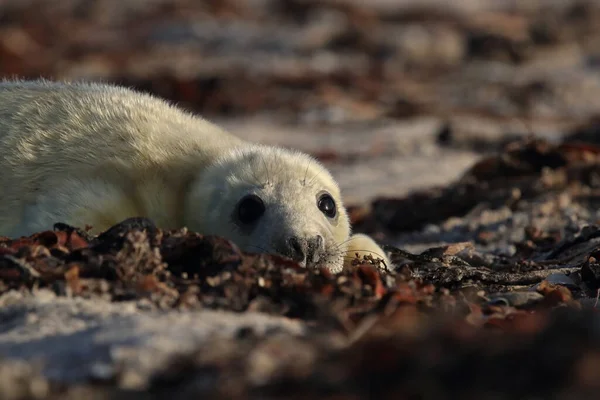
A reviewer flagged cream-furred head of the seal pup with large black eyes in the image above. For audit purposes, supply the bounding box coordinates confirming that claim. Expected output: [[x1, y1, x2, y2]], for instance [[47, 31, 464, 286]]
[[185, 145, 350, 272]]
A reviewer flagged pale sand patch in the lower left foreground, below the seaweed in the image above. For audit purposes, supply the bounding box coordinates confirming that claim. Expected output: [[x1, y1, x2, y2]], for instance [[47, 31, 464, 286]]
[[0, 291, 305, 390]]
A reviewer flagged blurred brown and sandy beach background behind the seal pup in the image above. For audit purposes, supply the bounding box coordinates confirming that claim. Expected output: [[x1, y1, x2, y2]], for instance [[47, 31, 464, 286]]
[[0, 0, 600, 204]]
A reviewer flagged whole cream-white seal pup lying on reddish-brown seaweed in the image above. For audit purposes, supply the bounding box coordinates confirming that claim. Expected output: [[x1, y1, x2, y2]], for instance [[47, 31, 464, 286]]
[[0, 80, 387, 272]]
